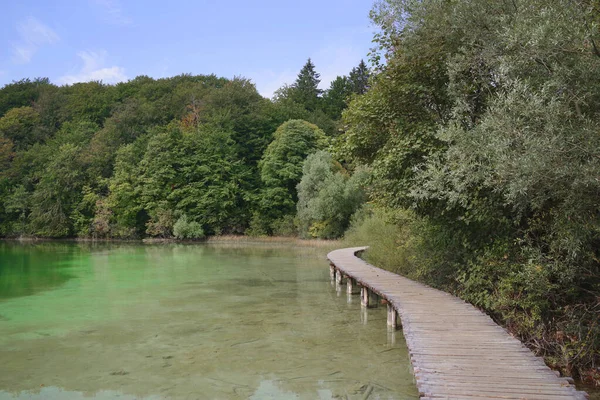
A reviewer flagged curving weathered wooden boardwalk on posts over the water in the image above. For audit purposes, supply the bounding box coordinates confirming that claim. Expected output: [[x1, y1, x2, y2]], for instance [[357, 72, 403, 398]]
[[327, 247, 587, 400]]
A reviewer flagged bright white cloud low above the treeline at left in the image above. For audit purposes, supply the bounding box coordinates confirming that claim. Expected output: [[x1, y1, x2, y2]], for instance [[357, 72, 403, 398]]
[[57, 51, 128, 85]]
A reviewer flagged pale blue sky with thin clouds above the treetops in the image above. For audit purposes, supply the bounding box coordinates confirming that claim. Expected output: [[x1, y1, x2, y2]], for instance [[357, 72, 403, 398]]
[[0, 0, 375, 97]]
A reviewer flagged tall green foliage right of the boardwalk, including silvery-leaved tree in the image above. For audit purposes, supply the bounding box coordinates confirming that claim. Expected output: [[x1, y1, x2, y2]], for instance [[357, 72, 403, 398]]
[[336, 0, 600, 377]]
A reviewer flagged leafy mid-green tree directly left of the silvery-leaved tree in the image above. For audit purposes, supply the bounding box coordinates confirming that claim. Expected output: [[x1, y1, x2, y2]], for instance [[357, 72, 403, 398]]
[[336, 43, 451, 207]]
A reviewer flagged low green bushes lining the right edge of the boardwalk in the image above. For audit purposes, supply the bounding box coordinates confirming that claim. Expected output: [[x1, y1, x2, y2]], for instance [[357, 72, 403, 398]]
[[345, 205, 600, 383]]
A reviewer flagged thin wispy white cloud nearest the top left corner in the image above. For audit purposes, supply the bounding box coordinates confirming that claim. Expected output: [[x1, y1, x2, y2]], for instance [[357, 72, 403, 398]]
[[12, 17, 60, 64]]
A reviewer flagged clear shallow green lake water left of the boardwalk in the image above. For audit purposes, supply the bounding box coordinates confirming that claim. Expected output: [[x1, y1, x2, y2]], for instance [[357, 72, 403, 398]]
[[0, 243, 418, 400]]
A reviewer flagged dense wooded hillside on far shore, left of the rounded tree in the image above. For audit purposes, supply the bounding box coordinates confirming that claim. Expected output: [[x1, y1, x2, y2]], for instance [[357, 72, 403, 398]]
[[0, 75, 284, 238]]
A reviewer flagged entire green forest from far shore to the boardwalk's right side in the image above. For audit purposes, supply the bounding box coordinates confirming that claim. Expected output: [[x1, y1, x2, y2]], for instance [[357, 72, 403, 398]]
[[0, 0, 600, 384]]
